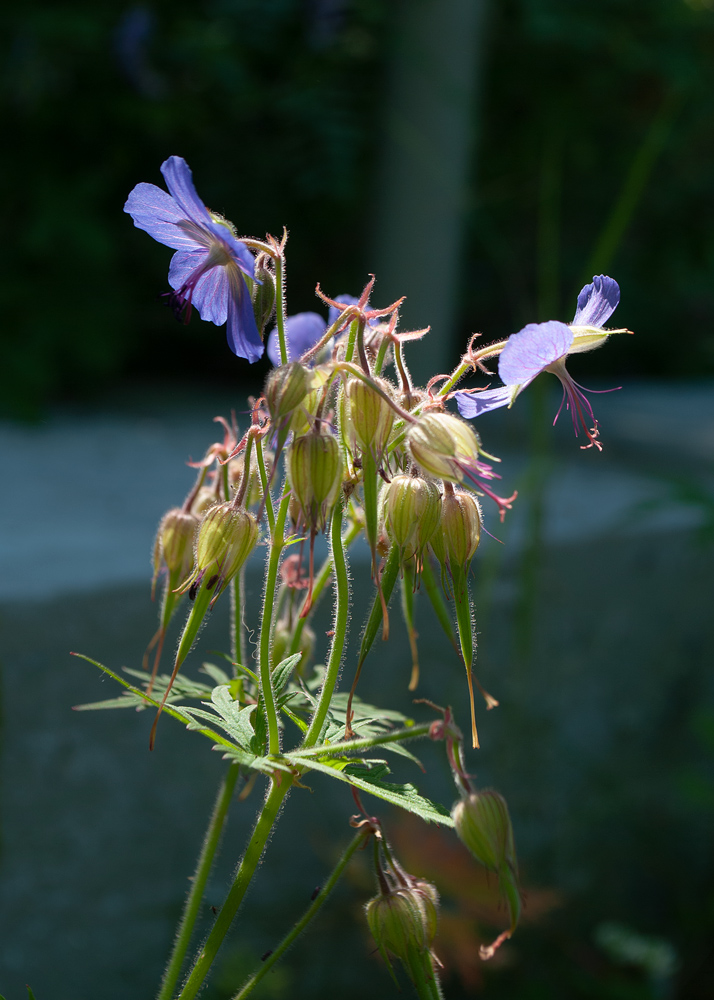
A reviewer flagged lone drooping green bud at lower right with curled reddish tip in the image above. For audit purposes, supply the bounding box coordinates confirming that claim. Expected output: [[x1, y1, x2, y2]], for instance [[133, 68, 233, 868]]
[[451, 788, 521, 958]]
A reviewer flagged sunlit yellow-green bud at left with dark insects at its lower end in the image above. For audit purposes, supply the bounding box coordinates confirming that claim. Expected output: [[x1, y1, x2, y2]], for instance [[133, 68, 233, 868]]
[[181, 501, 258, 605]]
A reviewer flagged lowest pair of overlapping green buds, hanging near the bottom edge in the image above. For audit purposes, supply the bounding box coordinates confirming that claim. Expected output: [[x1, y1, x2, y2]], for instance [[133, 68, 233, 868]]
[[365, 844, 439, 984]]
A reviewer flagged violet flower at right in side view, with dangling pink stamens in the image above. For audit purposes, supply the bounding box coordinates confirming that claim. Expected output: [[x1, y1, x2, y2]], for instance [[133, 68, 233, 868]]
[[454, 274, 627, 448]]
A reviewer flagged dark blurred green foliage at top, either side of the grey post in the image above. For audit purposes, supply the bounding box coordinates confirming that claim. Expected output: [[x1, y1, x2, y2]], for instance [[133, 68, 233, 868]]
[[0, 0, 714, 417]]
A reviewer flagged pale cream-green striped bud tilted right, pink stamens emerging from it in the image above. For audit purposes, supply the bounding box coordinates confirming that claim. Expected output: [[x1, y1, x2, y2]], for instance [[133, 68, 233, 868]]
[[407, 413, 479, 483]]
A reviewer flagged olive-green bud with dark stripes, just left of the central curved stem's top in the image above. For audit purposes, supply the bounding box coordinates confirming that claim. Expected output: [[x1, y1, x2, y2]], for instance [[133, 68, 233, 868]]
[[287, 431, 342, 531]]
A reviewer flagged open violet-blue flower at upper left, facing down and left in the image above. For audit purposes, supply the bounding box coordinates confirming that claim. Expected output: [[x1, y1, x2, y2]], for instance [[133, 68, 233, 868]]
[[124, 156, 263, 362]]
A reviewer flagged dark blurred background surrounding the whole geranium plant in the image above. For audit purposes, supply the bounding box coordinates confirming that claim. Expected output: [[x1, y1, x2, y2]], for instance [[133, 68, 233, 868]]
[[0, 0, 714, 1000]]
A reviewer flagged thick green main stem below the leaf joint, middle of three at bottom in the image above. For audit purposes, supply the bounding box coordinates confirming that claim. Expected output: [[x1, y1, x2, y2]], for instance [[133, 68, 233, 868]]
[[179, 773, 292, 1000]]
